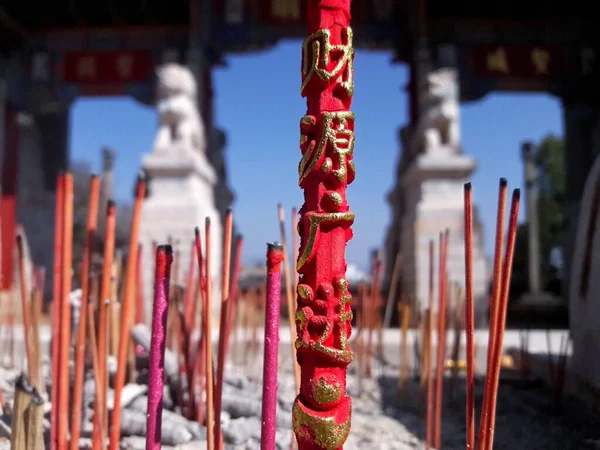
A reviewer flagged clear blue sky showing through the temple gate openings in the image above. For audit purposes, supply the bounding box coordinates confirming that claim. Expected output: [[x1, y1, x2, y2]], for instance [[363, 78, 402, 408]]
[[71, 41, 563, 268]]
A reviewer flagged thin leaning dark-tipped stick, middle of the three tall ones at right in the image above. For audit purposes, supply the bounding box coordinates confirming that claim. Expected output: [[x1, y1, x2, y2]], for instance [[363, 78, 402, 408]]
[[479, 178, 507, 450]]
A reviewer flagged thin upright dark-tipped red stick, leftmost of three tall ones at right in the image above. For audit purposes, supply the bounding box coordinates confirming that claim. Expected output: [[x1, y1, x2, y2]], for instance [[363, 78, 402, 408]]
[[465, 183, 475, 450]]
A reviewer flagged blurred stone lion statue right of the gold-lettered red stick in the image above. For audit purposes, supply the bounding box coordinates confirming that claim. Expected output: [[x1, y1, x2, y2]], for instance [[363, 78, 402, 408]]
[[411, 69, 460, 153]]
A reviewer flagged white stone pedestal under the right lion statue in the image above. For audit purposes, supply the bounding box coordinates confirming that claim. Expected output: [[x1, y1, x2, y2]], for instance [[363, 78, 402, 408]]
[[400, 151, 487, 317]]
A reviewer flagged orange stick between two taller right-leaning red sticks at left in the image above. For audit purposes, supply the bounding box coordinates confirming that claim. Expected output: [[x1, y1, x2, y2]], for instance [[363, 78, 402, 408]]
[[92, 201, 116, 450]]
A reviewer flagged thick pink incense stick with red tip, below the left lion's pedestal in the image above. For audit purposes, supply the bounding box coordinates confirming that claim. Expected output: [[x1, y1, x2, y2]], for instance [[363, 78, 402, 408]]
[[146, 245, 173, 450]]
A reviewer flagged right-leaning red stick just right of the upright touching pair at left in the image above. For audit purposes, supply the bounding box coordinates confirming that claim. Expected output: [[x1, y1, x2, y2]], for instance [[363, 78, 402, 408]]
[[71, 175, 101, 450]]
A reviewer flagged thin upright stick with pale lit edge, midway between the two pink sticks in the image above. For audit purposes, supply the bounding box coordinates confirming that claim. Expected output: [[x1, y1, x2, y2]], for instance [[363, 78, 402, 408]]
[[204, 217, 215, 450]]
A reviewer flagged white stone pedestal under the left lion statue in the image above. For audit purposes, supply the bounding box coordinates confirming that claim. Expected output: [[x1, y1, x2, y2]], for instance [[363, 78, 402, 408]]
[[140, 148, 223, 324]]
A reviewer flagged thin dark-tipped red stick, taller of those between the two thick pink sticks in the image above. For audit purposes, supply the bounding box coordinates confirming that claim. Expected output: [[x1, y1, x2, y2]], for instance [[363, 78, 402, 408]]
[[215, 210, 233, 450]]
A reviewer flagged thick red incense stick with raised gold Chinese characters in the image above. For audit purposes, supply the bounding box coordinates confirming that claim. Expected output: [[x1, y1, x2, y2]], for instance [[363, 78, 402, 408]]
[[292, 0, 355, 450]]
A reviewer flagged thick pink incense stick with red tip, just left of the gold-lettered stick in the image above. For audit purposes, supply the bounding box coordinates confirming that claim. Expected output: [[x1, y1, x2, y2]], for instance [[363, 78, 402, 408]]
[[260, 243, 283, 450]]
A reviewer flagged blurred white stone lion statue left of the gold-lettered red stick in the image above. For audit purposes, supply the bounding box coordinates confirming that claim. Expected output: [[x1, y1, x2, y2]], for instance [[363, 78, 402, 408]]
[[154, 63, 206, 153]]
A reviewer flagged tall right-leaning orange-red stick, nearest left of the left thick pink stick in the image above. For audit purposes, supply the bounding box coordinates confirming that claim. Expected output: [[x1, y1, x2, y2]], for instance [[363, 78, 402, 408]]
[[110, 178, 146, 450]]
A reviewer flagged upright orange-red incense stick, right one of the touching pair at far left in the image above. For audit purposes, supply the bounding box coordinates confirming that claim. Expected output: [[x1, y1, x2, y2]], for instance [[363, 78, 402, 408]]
[[58, 173, 73, 450]]
